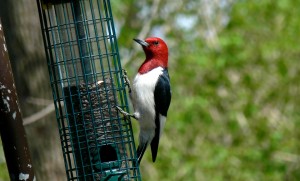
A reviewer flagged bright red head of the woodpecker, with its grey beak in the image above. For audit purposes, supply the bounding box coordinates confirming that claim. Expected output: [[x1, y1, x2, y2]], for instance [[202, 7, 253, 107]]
[[134, 37, 168, 73]]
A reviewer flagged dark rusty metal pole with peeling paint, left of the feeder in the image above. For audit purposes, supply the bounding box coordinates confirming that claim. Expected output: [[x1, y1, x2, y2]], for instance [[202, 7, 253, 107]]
[[0, 19, 35, 181]]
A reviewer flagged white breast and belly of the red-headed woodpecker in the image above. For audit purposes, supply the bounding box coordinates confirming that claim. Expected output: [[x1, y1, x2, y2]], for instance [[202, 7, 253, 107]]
[[132, 67, 163, 130]]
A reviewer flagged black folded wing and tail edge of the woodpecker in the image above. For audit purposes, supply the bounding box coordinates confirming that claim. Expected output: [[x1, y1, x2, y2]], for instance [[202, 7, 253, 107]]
[[151, 69, 171, 162]]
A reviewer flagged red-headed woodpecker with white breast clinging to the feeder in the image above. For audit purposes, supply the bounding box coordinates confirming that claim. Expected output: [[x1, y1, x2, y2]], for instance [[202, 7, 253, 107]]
[[130, 37, 171, 163]]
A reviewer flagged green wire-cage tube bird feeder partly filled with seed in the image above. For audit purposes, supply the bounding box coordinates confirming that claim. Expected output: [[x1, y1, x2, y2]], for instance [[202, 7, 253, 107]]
[[37, 0, 141, 180]]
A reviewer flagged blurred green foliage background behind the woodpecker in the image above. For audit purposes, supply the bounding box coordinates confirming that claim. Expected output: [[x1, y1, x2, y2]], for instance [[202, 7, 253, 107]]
[[0, 0, 300, 181]]
